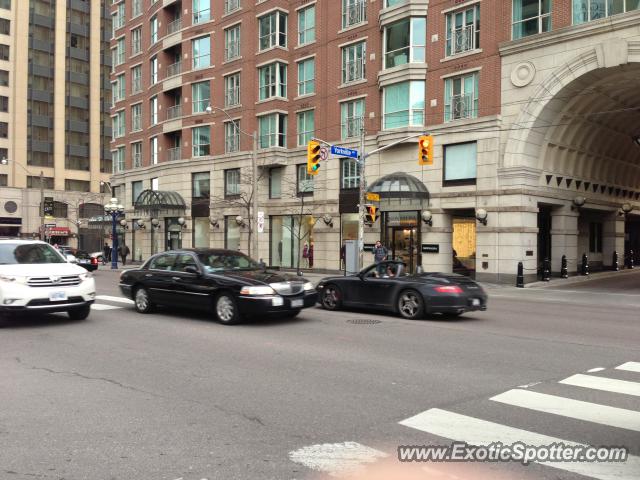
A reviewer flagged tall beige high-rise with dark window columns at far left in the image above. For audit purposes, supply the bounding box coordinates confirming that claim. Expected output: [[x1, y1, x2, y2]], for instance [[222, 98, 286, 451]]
[[0, 0, 111, 250]]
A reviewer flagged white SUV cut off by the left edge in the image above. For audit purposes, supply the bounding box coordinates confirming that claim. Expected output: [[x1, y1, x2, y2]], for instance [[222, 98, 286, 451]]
[[0, 240, 96, 320]]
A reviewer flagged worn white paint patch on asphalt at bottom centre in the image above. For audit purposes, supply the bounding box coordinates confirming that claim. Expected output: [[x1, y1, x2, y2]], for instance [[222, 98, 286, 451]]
[[289, 442, 388, 477]]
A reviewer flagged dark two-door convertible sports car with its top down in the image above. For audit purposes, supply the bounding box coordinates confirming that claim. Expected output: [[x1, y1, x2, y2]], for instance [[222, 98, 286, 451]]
[[316, 261, 487, 319]]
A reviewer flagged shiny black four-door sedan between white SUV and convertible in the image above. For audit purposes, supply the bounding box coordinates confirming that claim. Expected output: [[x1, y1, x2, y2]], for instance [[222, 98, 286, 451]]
[[120, 249, 318, 325]]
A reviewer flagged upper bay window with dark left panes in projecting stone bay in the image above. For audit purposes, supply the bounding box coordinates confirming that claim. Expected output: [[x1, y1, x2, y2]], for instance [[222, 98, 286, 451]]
[[384, 18, 427, 68]]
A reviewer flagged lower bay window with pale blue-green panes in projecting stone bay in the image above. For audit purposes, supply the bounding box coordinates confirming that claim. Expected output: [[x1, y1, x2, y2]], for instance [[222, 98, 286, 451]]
[[383, 81, 425, 130]]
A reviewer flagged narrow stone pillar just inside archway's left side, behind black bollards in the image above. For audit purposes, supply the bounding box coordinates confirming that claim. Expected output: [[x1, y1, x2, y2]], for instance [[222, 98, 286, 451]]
[[551, 206, 581, 274]]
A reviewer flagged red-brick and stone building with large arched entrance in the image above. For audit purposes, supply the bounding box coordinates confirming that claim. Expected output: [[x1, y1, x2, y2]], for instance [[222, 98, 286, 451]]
[[111, 0, 640, 282]]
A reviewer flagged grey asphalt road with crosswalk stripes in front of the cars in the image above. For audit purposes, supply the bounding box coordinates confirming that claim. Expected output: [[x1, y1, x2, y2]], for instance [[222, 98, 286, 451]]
[[0, 270, 640, 480]]
